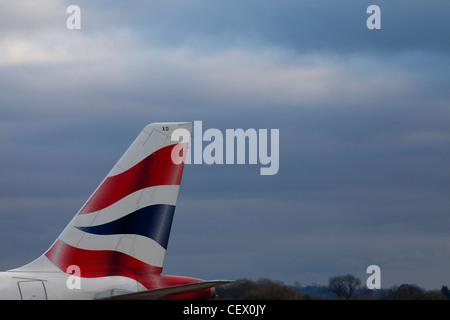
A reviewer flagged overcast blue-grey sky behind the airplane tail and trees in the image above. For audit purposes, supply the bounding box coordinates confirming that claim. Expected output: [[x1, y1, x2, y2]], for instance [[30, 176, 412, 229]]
[[0, 0, 450, 289]]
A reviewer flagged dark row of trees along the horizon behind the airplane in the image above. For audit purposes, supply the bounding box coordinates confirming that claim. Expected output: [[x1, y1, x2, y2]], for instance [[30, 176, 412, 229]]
[[216, 275, 450, 300]]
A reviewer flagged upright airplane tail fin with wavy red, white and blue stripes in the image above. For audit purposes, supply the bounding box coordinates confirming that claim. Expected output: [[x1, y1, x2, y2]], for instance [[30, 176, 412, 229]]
[[16, 122, 192, 278]]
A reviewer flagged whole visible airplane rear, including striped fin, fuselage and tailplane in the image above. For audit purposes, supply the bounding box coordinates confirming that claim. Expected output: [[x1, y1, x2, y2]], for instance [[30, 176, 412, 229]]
[[0, 122, 229, 299]]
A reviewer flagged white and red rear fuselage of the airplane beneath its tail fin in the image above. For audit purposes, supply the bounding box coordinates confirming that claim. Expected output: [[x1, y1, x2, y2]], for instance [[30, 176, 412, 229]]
[[0, 271, 215, 300]]
